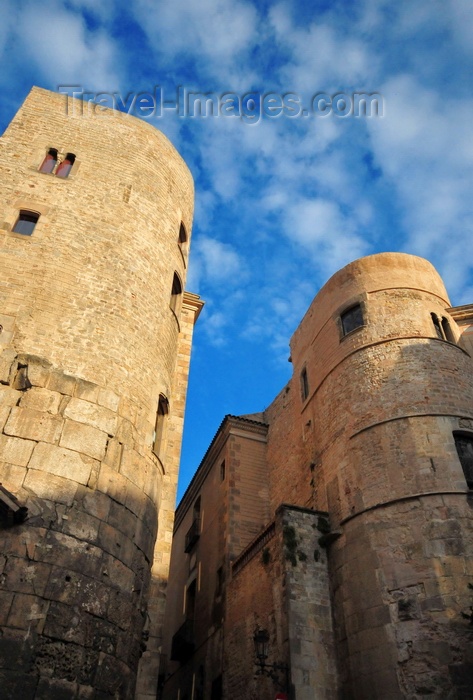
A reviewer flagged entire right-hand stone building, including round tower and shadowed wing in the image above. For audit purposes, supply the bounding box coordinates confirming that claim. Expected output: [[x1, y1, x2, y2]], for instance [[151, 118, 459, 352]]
[[160, 253, 473, 700]]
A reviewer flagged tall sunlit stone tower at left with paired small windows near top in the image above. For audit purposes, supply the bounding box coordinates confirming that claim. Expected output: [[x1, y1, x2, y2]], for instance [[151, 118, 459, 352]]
[[0, 88, 202, 700]]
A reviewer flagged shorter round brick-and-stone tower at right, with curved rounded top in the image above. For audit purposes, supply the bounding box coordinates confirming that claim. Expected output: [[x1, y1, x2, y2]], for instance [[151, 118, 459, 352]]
[[291, 253, 473, 700]]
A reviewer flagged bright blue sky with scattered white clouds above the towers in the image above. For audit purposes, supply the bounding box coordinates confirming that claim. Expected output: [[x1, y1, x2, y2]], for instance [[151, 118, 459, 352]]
[[0, 0, 473, 504]]
